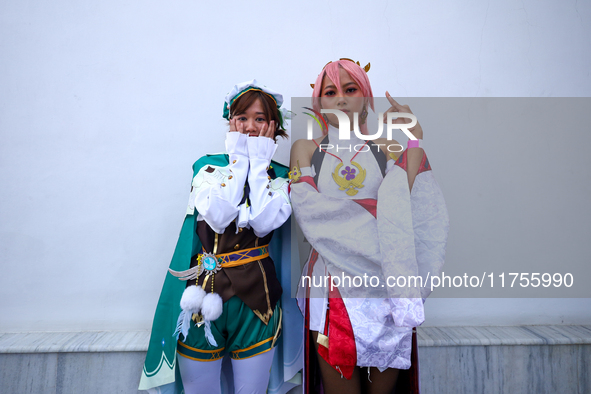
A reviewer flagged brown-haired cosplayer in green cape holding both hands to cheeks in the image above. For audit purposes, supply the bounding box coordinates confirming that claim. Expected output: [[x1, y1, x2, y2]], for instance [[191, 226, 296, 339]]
[[140, 80, 291, 394]]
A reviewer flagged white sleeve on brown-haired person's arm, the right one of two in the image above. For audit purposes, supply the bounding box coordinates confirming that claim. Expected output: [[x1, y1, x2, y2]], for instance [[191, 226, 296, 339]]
[[248, 137, 291, 237]]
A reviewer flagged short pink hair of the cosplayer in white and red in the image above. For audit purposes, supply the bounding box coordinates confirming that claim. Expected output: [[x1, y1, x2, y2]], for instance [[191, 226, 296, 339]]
[[312, 60, 375, 135]]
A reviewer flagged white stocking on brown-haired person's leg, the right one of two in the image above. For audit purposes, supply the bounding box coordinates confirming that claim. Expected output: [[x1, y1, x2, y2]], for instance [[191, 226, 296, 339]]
[[232, 348, 275, 394]]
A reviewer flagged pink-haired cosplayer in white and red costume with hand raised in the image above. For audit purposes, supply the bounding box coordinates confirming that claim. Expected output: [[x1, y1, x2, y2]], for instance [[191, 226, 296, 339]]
[[290, 59, 449, 394]]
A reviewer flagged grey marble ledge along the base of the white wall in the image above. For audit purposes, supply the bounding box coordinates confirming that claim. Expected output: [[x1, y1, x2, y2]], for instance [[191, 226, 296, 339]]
[[0, 326, 591, 394]]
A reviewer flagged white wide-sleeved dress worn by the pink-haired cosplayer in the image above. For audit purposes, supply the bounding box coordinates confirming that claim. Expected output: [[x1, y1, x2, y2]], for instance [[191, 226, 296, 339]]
[[291, 126, 448, 370]]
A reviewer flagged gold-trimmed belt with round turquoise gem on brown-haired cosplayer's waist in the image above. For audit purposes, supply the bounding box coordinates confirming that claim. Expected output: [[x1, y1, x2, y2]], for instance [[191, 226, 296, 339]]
[[168, 245, 269, 280]]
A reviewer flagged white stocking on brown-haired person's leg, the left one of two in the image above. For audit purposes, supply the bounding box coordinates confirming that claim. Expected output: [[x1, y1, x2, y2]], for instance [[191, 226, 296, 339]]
[[177, 355, 222, 394]]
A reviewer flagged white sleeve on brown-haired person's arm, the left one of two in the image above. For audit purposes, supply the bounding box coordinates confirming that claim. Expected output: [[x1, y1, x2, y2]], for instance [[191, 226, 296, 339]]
[[191, 132, 249, 234]]
